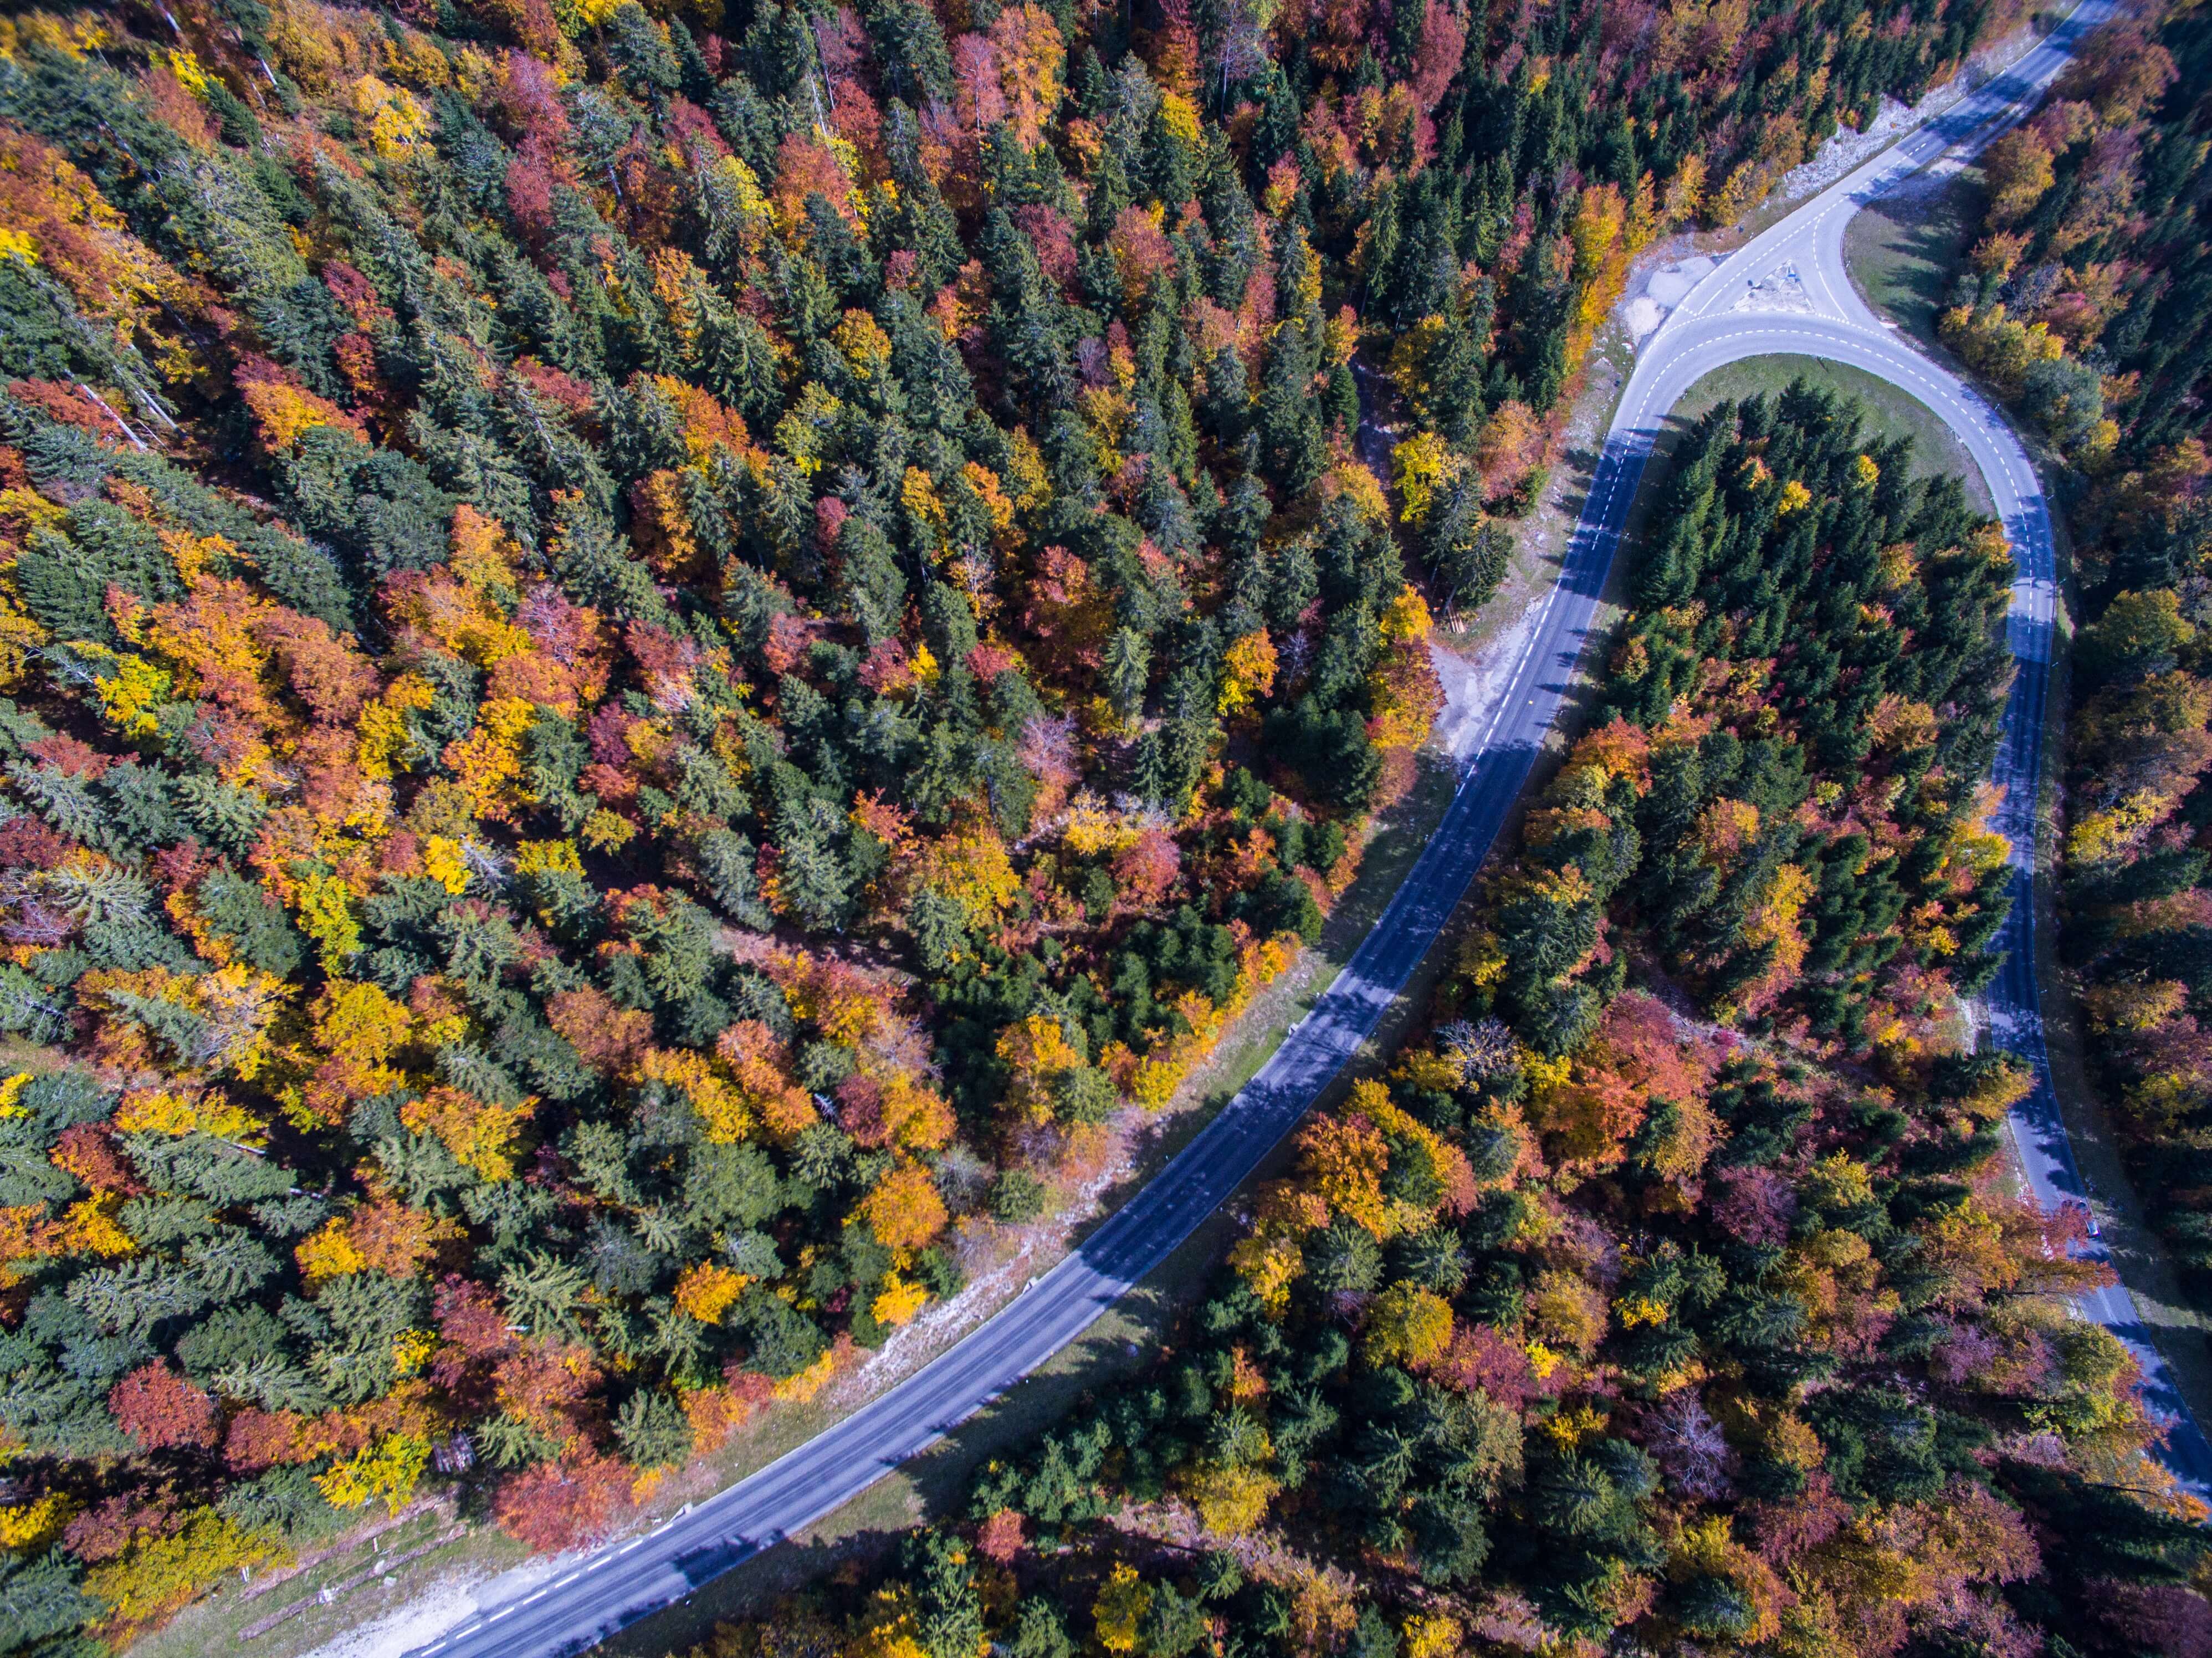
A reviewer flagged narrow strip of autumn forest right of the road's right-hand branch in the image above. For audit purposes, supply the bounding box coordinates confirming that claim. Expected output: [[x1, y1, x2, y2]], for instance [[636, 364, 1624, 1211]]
[[1944, 7, 2212, 1304]]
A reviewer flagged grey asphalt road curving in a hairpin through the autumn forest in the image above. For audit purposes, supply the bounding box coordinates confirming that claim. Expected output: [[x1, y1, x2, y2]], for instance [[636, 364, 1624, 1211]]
[[412, 0, 2212, 1658]]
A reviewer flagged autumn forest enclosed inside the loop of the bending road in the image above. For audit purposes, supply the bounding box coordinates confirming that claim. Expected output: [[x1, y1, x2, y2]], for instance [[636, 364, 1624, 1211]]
[[654, 383, 2212, 1658]]
